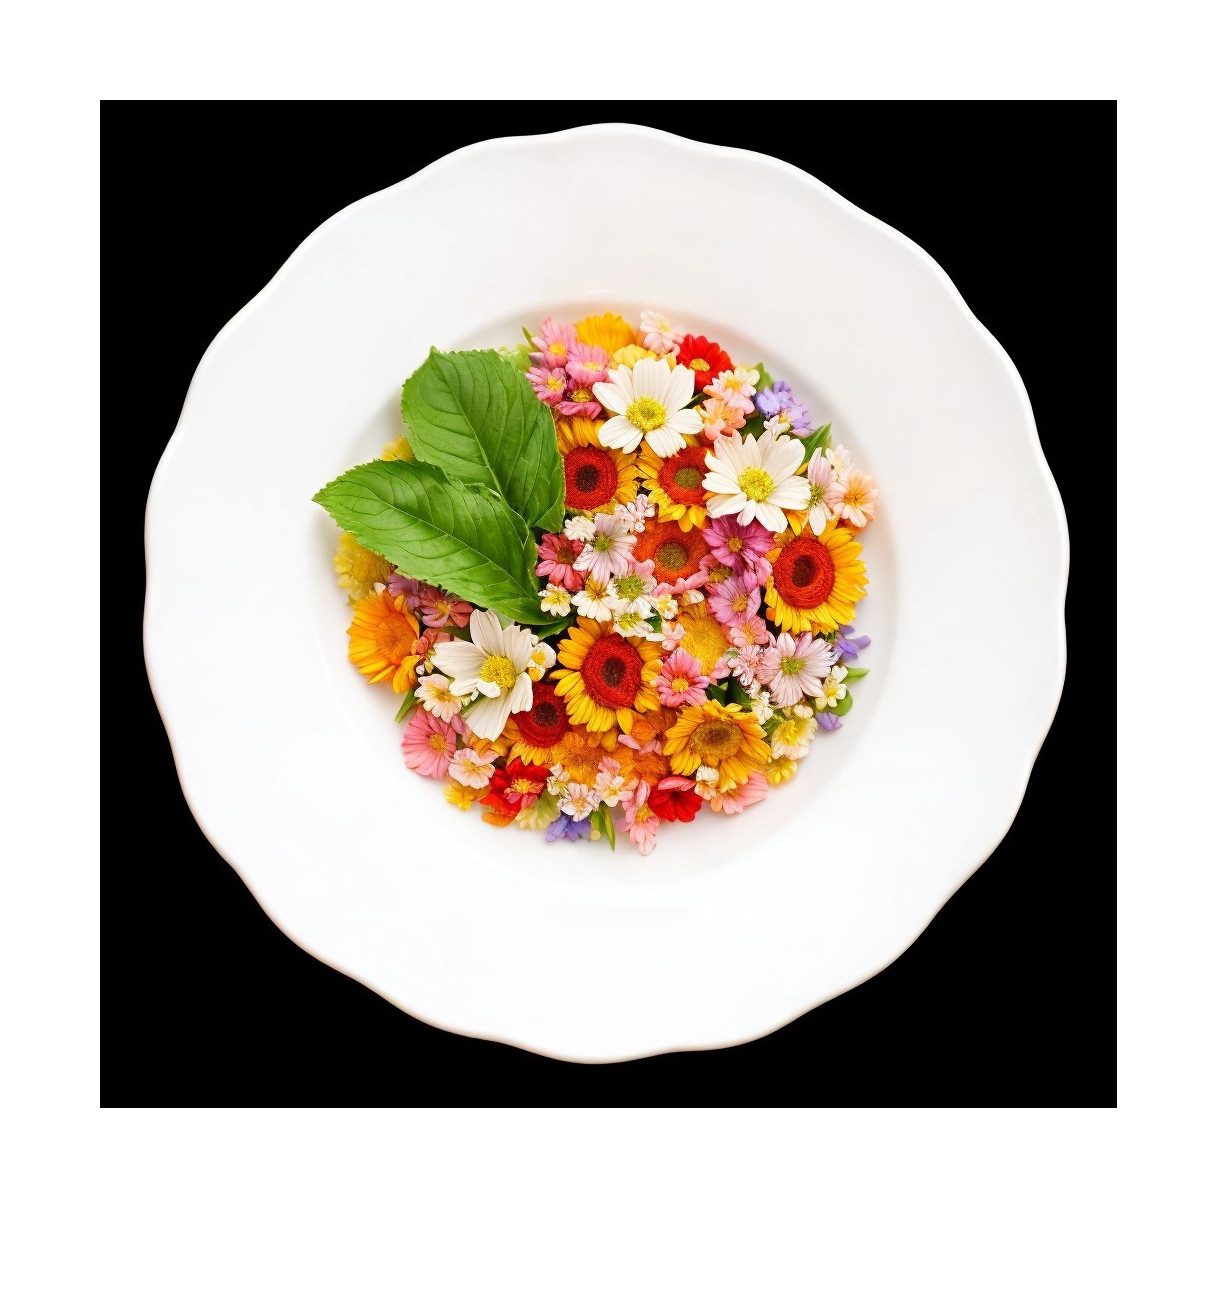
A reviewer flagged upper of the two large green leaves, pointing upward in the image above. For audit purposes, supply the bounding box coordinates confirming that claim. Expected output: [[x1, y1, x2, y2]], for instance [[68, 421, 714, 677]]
[[401, 350, 565, 534]]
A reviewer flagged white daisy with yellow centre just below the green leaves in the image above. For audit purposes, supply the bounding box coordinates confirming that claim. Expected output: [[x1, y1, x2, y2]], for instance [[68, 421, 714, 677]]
[[435, 609, 537, 741]]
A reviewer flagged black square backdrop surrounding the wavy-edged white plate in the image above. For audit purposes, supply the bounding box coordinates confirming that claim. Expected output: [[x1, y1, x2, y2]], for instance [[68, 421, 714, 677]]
[[103, 103, 1115, 1105]]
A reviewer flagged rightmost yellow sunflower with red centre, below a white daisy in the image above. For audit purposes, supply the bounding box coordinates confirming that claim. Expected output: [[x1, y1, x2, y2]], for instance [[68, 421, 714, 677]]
[[764, 526, 867, 636]]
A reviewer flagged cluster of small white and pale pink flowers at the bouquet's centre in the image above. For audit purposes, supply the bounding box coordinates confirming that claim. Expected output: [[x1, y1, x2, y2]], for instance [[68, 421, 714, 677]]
[[541, 495, 679, 640]]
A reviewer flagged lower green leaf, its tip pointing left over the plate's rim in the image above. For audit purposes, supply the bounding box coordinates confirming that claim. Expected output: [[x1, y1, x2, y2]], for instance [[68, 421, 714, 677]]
[[313, 459, 554, 632]]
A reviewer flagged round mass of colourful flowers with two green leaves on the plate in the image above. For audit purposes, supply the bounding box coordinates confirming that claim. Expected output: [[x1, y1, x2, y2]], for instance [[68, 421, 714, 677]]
[[314, 312, 878, 855]]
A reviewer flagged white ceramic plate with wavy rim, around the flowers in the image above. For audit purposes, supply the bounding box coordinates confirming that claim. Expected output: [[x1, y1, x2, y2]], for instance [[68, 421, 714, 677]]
[[145, 126, 1068, 1060]]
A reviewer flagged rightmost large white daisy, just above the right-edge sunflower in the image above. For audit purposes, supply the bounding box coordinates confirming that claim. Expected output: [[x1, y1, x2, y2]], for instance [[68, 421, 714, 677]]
[[702, 432, 810, 531]]
